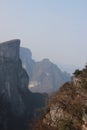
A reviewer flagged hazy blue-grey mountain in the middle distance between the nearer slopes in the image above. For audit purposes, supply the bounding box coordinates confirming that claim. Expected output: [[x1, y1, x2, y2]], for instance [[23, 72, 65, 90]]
[[20, 48, 70, 93]]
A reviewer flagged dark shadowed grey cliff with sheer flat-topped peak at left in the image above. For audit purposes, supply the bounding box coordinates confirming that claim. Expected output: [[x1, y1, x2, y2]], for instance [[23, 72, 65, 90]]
[[0, 40, 45, 130]]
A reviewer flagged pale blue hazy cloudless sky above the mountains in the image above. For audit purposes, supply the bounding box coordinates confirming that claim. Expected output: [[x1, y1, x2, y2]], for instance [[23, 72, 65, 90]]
[[0, 0, 87, 67]]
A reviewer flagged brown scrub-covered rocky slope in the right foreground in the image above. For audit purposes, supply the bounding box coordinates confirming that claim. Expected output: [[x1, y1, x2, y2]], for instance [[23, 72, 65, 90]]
[[31, 66, 87, 130]]
